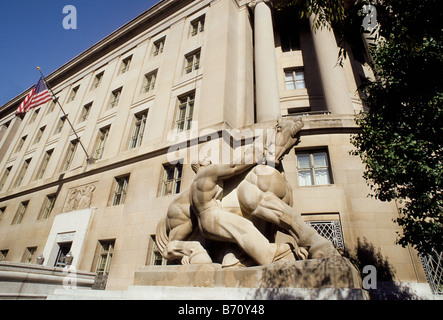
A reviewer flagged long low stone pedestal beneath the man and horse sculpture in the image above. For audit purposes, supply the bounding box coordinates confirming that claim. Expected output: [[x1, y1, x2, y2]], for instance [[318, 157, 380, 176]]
[[134, 257, 367, 299]]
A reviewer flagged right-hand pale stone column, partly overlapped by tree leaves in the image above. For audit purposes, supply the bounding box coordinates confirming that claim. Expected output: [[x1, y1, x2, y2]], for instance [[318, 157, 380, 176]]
[[309, 15, 354, 114]]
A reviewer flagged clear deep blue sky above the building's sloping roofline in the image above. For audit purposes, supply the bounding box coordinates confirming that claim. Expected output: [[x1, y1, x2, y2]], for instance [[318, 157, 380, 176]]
[[0, 0, 159, 106]]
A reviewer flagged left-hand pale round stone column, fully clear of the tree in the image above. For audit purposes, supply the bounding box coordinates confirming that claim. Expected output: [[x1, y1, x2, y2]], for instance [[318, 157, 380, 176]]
[[249, 0, 280, 122]]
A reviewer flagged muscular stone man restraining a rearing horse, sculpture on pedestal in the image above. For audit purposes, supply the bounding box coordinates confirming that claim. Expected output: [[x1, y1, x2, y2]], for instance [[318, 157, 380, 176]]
[[156, 117, 339, 267]]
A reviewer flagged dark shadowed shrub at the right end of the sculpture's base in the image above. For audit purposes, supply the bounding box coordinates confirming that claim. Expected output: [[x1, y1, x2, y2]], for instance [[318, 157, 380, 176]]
[[343, 238, 420, 300]]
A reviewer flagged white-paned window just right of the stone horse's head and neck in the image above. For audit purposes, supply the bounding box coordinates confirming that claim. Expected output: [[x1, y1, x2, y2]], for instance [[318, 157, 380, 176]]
[[297, 151, 332, 186]]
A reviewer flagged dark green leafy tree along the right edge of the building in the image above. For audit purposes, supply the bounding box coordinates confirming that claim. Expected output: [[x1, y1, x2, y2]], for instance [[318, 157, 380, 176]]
[[351, 0, 443, 254]]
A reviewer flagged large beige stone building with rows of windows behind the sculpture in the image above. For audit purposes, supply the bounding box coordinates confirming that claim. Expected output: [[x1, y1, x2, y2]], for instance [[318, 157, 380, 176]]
[[0, 0, 441, 293]]
